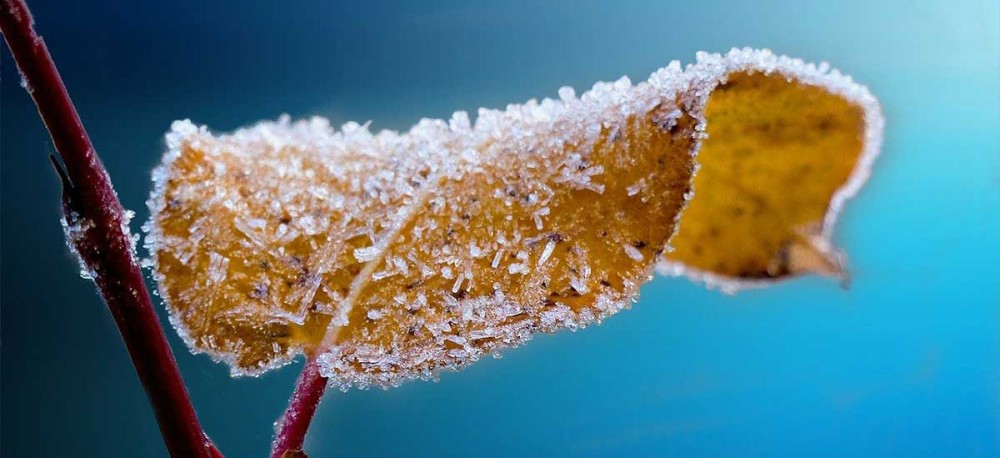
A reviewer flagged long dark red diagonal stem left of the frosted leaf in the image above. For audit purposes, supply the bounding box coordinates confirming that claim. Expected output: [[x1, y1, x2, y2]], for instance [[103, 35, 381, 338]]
[[0, 0, 222, 457]]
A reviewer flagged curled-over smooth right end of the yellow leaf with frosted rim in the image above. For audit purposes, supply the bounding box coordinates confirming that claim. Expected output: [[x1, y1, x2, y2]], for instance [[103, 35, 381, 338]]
[[658, 53, 883, 291]]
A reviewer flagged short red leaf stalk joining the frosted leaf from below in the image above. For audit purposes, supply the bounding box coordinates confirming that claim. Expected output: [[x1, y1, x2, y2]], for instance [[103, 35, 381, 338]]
[[271, 358, 327, 458]]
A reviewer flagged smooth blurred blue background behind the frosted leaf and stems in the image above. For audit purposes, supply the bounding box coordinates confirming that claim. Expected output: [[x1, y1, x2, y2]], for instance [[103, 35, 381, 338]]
[[0, 0, 1000, 457]]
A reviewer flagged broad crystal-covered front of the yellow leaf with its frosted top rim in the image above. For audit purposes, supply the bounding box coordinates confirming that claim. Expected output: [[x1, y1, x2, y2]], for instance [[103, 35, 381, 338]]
[[146, 50, 881, 388]]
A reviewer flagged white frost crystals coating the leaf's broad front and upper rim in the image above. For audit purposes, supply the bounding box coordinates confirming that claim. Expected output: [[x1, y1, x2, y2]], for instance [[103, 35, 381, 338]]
[[144, 50, 881, 382]]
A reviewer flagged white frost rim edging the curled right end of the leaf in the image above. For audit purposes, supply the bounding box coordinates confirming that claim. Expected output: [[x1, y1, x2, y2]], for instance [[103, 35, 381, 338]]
[[656, 48, 885, 294]]
